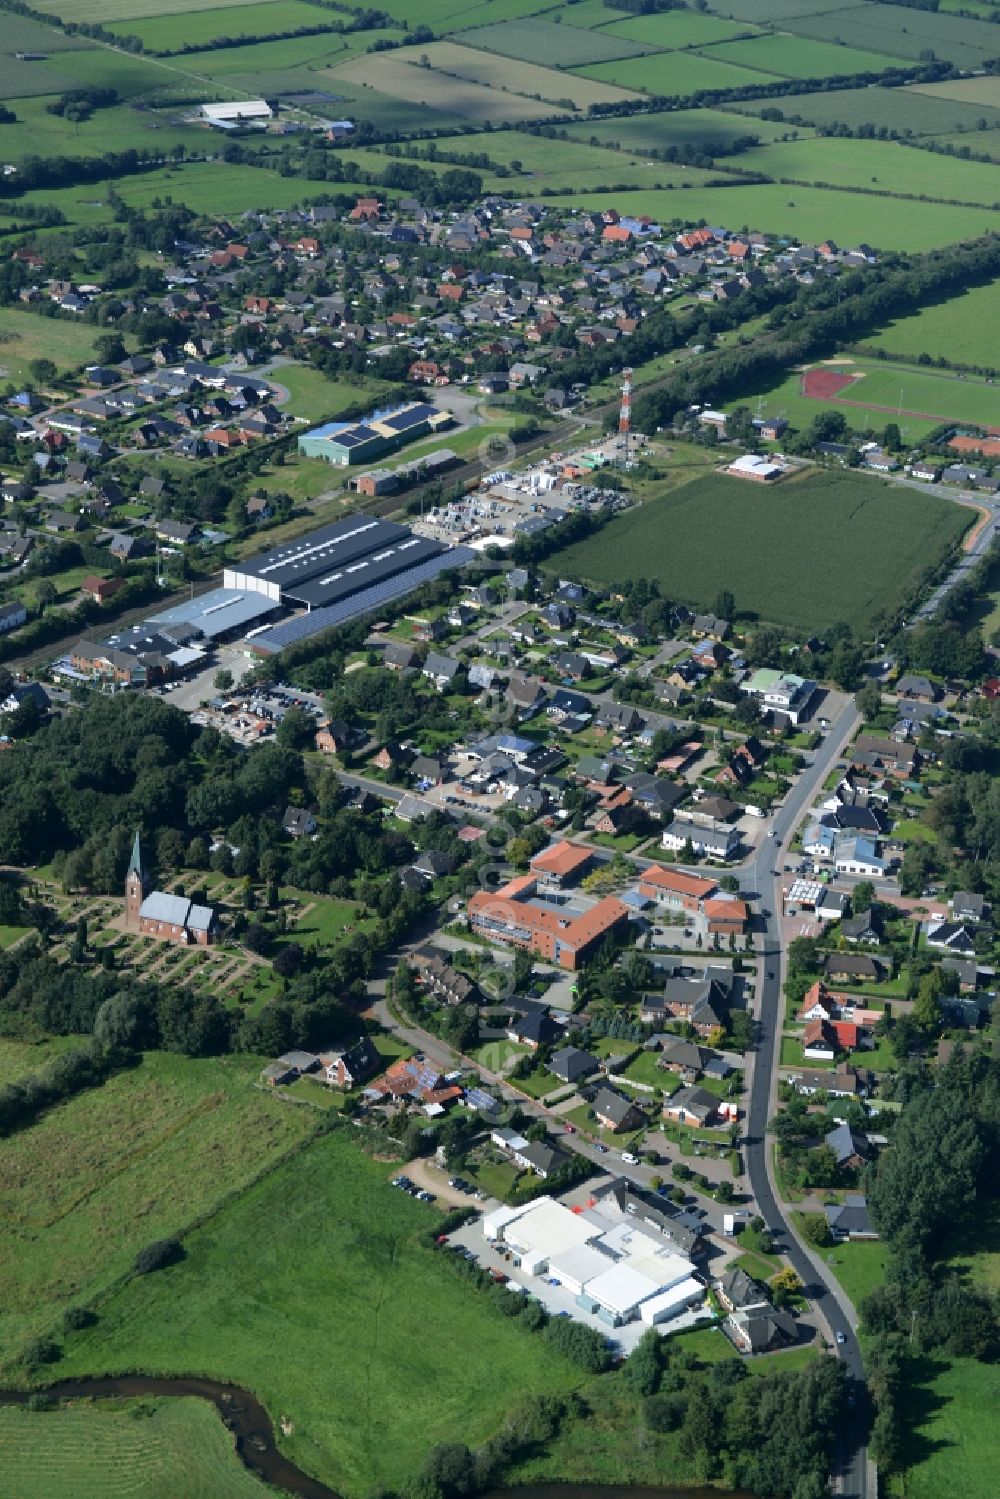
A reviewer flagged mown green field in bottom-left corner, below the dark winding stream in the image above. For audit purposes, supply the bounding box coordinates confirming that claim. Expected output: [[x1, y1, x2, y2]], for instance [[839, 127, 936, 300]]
[[0, 1397, 271, 1499]]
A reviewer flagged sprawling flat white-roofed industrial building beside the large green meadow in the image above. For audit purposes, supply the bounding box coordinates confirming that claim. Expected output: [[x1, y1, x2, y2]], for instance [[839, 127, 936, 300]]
[[483, 1198, 705, 1327]]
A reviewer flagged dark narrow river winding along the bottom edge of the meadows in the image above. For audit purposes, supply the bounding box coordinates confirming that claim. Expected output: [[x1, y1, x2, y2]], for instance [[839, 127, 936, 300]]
[[0, 1375, 753, 1499]]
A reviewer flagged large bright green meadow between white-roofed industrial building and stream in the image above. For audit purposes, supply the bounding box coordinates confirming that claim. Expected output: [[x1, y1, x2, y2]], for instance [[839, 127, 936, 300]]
[[60, 1111, 580, 1496]]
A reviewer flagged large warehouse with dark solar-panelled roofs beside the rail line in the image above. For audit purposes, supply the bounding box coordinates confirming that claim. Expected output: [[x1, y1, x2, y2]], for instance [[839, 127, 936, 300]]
[[223, 514, 475, 655]]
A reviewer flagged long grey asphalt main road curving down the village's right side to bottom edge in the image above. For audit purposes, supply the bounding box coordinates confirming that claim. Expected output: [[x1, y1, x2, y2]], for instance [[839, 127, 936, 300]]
[[742, 702, 876, 1499]]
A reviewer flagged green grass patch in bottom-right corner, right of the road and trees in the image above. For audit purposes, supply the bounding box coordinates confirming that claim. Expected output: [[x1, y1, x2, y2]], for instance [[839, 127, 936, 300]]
[[892, 1358, 1000, 1499]]
